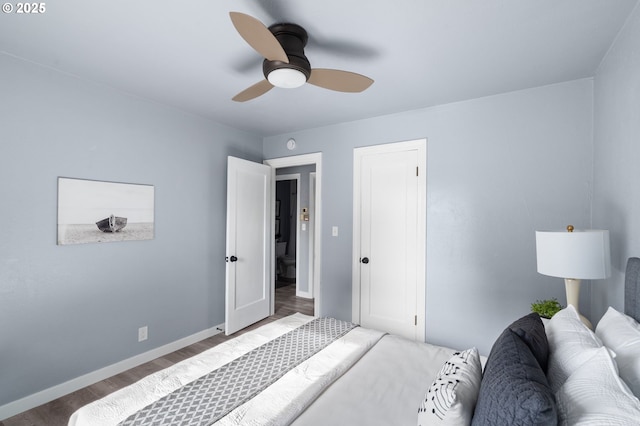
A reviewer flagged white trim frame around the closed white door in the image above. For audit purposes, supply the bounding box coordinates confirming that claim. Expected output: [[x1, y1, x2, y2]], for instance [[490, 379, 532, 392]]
[[351, 139, 427, 341]]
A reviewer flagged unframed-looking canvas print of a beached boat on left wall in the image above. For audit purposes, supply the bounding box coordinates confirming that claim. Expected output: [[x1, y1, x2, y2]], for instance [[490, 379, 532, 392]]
[[58, 177, 155, 245]]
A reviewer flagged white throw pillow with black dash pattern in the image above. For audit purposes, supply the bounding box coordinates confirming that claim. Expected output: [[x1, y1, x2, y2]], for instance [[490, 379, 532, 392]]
[[418, 348, 482, 426]]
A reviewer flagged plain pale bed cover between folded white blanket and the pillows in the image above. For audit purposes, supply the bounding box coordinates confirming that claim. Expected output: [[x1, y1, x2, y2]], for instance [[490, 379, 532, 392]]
[[293, 335, 455, 426]]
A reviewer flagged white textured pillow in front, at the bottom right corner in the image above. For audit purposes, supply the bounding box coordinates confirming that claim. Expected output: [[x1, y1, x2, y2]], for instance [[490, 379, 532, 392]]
[[556, 347, 640, 426]]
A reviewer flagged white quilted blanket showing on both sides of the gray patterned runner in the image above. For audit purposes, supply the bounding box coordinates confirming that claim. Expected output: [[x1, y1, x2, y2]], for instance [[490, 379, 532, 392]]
[[69, 314, 384, 426]]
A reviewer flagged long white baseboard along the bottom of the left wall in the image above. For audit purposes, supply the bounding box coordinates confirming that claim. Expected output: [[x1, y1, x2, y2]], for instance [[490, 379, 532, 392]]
[[0, 324, 224, 421]]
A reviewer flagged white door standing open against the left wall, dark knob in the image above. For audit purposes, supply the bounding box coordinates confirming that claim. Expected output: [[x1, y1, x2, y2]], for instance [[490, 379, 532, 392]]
[[225, 157, 273, 335]]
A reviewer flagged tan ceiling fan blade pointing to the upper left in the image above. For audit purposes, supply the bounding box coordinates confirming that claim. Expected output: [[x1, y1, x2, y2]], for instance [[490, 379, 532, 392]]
[[229, 12, 289, 64]]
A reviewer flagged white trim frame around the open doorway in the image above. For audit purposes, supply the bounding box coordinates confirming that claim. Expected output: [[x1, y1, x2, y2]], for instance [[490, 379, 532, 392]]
[[264, 152, 322, 316]]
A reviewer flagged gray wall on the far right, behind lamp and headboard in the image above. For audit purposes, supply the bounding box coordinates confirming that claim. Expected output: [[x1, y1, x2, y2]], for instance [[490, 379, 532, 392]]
[[591, 7, 640, 319]]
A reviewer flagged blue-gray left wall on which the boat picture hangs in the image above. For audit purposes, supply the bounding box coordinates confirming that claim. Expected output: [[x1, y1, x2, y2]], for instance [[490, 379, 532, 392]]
[[0, 54, 262, 406]]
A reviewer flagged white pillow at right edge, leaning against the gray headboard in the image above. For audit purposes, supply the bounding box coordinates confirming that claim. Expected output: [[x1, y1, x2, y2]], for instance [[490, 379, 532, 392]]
[[596, 307, 640, 397]]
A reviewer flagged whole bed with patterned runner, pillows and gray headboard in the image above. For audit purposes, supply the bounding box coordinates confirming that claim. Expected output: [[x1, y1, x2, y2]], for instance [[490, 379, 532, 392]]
[[69, 258, 640, 426]]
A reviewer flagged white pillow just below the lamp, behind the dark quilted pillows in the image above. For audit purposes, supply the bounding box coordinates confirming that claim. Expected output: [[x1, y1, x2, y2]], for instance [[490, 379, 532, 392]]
[[545, 305, 602, 393]]
